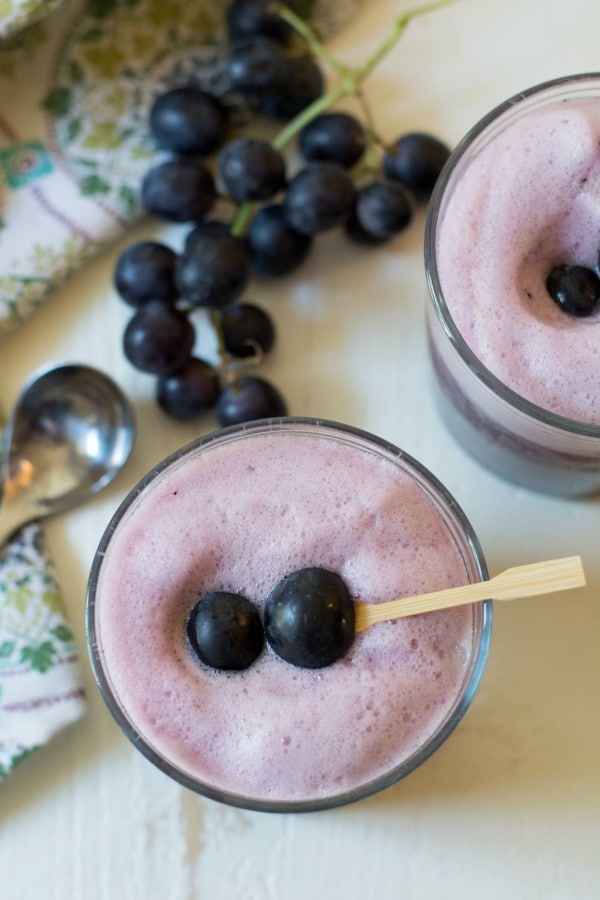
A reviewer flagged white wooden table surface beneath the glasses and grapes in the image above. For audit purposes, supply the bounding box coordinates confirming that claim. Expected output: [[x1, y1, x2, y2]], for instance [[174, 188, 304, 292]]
[[0, 0, 600, 900]]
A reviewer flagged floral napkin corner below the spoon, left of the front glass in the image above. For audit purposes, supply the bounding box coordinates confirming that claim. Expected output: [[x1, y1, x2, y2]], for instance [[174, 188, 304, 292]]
[[0, 410, 86, 781]]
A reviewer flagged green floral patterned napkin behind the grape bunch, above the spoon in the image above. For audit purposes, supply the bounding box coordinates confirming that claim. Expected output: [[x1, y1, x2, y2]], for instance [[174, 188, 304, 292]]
[[0, 0, 359, 335]]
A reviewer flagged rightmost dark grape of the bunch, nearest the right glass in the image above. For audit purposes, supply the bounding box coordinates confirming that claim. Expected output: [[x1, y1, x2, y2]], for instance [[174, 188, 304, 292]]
[[383, 131, 450, 198]]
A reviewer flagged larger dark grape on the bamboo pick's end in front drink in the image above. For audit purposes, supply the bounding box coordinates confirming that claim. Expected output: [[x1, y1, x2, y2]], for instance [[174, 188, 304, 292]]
[[265, 567, 355, 669]]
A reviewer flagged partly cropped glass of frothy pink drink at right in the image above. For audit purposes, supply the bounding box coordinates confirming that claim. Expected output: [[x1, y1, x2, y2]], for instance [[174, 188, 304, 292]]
[[425, 75, 600, 494]]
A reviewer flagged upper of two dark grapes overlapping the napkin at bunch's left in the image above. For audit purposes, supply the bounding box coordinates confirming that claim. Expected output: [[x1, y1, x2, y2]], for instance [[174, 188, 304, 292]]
[[150, 87, 228, 156]]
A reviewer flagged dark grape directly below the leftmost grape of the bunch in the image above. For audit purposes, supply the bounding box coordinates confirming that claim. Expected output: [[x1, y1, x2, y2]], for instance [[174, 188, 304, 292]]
[[123, 300, 195, 375]]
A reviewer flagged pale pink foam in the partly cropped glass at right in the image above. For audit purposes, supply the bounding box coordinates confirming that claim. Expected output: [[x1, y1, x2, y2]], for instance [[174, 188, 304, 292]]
[[437, 98, 600, 425]]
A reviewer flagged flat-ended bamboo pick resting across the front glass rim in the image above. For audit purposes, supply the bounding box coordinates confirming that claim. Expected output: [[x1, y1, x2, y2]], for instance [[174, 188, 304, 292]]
[[354, 556, 586, 632]]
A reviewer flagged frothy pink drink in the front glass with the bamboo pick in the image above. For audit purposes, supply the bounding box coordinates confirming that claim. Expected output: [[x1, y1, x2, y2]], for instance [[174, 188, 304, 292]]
[[89, 422, 489, 809]]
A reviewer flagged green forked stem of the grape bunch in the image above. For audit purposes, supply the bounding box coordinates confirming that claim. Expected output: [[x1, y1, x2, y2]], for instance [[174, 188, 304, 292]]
[[231, 0, 456, 236]]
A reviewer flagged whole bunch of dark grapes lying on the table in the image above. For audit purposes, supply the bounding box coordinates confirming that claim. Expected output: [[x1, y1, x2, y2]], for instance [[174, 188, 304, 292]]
[[115, 0, 449, 426]]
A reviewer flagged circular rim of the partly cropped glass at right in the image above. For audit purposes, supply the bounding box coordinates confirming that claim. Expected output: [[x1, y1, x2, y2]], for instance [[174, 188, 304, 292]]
[[424, 71, 600, 438]]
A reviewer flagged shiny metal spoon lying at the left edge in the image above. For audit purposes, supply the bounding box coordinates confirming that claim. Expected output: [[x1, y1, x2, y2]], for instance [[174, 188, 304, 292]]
[[0, 364, 135, 547]]
